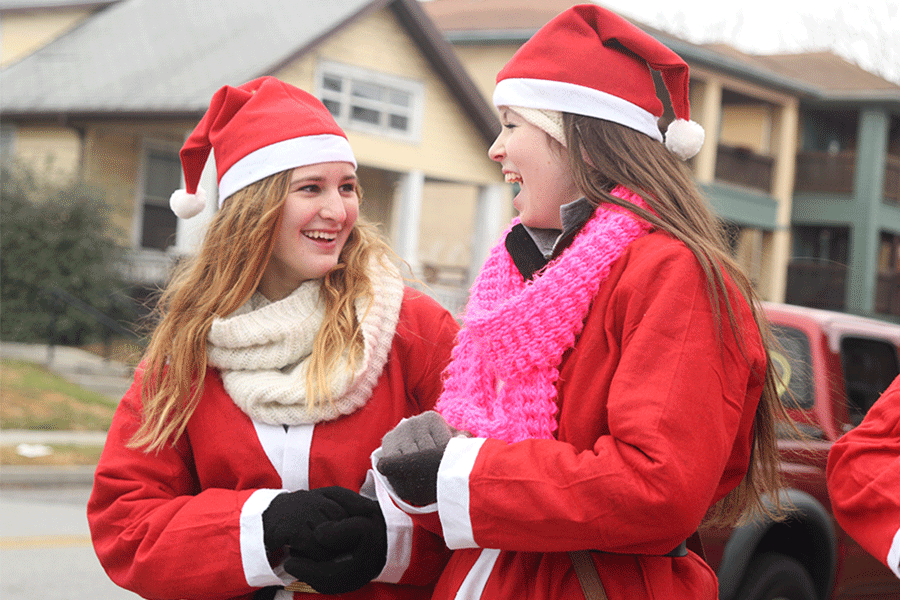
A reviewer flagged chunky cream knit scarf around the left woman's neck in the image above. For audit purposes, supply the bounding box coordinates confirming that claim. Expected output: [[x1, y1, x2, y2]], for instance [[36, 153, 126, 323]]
[[207, 263, 403, 425]]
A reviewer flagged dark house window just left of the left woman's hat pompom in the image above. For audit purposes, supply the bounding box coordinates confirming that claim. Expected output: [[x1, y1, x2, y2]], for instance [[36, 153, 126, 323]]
[[140, 147, 181, 250]]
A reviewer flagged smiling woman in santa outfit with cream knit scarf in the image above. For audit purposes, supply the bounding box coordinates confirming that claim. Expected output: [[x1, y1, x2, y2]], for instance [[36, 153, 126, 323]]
[[88, 77, 458, 600]]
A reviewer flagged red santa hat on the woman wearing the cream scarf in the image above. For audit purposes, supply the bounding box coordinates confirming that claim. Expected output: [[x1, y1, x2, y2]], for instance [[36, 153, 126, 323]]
[[169, 77, 356, 219]]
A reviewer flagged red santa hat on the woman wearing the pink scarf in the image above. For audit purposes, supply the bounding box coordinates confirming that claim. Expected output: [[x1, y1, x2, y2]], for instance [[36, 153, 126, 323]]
[[494, 4, 704, 160]]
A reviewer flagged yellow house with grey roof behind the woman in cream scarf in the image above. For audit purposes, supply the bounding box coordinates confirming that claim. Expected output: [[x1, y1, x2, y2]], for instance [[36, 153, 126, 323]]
[[0, 0, 511, 310]]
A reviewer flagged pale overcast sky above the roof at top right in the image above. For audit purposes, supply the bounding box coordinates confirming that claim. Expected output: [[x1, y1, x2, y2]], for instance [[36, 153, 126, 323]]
[[599, 0, 900, 83]]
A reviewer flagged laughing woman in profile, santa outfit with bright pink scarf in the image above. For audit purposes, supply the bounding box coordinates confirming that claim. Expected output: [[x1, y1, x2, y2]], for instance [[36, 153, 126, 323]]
[[373, 5, 784, 600]]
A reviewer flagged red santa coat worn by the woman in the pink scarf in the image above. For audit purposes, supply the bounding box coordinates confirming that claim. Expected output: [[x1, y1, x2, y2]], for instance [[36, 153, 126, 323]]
[[373, 232, 766, 600]]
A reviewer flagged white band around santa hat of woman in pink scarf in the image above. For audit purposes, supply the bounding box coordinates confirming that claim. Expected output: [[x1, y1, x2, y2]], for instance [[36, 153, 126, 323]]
[[494, 78, 663, 142]]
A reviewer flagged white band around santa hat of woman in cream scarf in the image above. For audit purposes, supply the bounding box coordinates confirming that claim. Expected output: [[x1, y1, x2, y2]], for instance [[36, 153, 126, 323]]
[[219, 134, 356, 208]]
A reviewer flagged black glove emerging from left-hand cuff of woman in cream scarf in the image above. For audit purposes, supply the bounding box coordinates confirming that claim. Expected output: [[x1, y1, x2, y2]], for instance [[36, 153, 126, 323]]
[[263, 488, 350, 559]]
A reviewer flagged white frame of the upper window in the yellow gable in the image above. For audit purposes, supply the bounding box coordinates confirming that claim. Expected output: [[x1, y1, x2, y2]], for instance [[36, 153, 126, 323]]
[[316, 60, 425, 142]]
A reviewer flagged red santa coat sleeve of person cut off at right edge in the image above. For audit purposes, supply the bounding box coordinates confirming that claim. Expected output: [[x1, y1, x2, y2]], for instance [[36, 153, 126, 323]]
[[827, 377, 900, 577]]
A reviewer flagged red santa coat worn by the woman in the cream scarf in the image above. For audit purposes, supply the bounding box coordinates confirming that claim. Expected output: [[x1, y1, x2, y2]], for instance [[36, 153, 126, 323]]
[[88, 289, 458, 600]]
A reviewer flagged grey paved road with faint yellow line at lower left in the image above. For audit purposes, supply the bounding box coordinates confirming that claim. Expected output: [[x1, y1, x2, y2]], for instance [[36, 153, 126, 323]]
[[0, 485, 139, 600]]
